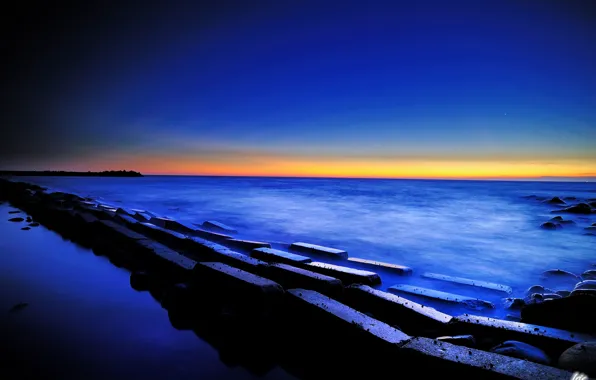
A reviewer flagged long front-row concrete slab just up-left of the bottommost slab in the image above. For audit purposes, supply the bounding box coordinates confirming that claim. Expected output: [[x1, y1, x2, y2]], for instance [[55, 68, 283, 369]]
[[286, 289, 410, 353]]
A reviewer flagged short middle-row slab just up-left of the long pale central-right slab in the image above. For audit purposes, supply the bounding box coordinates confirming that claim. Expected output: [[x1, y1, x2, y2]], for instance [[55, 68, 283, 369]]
[[265, 263, 343, 297]]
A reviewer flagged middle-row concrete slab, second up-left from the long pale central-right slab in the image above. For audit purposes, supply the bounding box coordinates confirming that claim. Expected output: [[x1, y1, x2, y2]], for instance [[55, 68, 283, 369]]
[[186, 236, 267, 274]]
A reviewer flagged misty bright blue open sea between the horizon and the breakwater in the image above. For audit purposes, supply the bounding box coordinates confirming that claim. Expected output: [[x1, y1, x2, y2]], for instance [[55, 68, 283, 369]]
[[18, 176, 596, 312]]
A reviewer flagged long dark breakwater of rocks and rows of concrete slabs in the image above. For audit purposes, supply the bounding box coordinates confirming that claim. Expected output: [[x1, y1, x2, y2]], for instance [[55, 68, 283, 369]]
[[1, 182, 593, 379]]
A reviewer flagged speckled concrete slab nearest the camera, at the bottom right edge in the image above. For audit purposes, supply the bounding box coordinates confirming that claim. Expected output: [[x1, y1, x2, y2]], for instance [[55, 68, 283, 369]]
[[399, 338, 572, 380]]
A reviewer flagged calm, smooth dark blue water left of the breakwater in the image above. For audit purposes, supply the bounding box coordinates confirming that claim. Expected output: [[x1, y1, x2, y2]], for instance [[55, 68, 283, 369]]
[[0, 204, 293, 380]]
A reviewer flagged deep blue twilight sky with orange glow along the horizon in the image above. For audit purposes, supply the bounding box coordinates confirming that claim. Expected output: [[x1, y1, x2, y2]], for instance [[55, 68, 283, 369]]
[[0, 0, 596, 178]]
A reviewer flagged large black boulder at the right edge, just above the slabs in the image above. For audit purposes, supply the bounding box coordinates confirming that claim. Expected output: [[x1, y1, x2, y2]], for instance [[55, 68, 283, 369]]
[[521, 294, 596, 333]]
